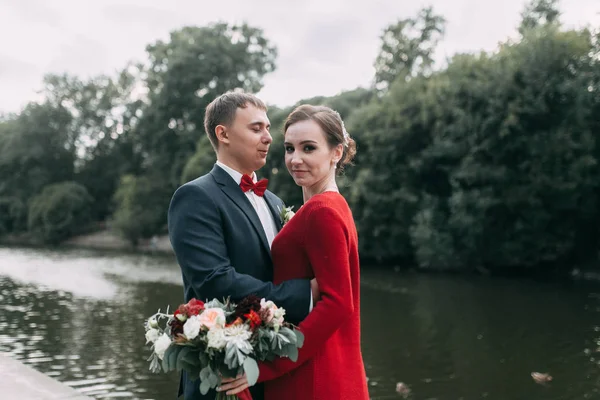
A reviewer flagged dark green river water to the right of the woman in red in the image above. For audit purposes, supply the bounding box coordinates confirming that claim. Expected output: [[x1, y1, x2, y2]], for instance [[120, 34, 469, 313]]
[[362, 272, 600, 400]]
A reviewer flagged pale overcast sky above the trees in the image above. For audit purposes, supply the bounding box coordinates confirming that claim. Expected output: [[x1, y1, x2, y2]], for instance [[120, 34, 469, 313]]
[[0, 0, 600, 112]]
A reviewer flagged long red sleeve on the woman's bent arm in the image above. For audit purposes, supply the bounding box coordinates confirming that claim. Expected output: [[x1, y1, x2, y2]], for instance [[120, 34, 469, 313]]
[[258, 205, 354, 382]]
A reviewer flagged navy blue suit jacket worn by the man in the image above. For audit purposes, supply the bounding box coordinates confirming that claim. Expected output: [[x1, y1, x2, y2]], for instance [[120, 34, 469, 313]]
[[168, 165, 311, 400]]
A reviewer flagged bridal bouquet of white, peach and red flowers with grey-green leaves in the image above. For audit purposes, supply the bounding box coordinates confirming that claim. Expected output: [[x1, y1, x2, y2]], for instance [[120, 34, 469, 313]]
[[145, 296, 304, 399]]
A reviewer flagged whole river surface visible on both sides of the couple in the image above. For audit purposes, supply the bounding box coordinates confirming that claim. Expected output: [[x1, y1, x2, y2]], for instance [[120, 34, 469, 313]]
[[0, 248, 600, 400]]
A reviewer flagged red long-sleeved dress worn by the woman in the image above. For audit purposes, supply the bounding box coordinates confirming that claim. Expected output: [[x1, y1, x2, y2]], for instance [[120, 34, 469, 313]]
[[258, 192, 369, 400]]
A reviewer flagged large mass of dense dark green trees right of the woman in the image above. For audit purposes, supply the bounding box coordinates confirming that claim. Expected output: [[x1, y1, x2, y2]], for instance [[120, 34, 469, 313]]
[[348, 17, 600, 270]]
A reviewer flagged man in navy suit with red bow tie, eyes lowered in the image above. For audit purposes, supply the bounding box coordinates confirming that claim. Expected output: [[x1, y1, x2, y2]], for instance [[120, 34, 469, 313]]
[[168, 92, 318, 400]]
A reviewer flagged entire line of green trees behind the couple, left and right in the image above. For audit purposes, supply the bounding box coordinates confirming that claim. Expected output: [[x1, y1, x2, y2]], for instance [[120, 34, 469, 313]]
[[0, 0, 600, 276]]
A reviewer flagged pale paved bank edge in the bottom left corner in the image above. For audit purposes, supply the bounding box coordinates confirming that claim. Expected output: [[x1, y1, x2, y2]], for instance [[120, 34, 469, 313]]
[[0, 353, 91, 400]]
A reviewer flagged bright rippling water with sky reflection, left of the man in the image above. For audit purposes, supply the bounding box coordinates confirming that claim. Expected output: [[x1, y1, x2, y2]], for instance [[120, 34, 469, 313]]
[[0, 249, 182, 399]]
